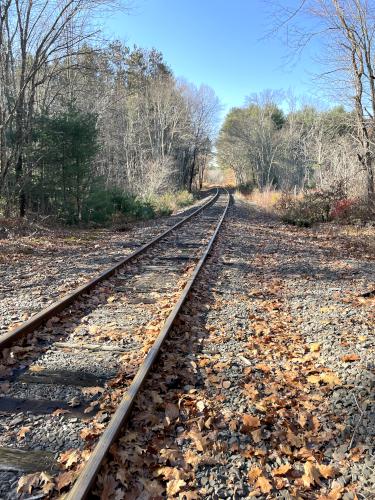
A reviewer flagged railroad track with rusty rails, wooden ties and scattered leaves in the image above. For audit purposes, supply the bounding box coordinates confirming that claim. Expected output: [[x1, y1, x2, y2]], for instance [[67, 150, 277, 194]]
[[0, 188, 230, 500]]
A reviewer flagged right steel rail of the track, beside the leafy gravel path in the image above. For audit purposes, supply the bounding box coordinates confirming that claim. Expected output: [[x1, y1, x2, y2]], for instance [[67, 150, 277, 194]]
[[64, 191, 231, 500]]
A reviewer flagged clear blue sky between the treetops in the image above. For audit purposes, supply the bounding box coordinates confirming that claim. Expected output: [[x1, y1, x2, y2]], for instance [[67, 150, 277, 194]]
[[103, 0, 326, 115]]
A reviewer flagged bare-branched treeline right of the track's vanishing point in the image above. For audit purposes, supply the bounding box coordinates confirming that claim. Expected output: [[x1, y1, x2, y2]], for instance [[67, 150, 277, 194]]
[[217, 93, 374, 197]]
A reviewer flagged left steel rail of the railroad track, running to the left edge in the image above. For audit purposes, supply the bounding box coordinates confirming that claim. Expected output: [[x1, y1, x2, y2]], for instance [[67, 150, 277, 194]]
[[0, 189, 219, 349]]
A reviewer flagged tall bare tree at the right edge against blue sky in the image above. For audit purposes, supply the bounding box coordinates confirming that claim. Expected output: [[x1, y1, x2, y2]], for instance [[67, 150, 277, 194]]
[[278, 0, 375, 198]]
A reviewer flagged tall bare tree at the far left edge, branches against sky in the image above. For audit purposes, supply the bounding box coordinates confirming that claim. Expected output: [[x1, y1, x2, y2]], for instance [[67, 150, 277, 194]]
[[0, 0, 117, 216]]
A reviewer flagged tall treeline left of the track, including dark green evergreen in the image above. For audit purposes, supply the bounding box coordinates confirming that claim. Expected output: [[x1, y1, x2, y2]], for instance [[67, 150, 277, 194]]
[[0, 0, 219, 223]]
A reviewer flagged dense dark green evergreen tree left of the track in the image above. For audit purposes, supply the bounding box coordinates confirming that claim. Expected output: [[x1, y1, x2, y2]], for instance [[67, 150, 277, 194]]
[[31, 108, 98, 222]]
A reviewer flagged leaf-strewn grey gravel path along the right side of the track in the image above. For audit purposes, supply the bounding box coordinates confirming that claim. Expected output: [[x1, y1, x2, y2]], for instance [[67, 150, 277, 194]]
[[94, 200, 375, 500]]
